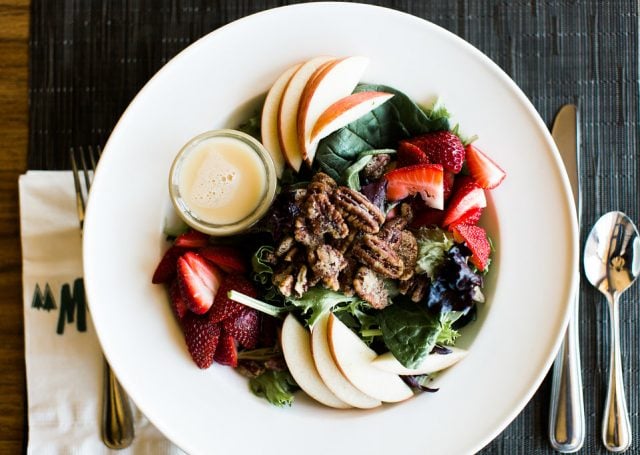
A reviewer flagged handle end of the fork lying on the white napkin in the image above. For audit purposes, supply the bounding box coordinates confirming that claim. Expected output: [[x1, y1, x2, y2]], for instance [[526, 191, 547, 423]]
[[102, 359, 135, 449]]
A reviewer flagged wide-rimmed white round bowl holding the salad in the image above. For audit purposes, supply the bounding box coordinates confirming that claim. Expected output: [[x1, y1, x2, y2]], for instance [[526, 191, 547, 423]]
[[84, 3, 578, 455]]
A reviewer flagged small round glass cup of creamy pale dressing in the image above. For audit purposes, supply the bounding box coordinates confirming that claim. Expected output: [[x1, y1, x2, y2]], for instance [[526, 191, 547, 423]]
[[169, 129, 277, 236]]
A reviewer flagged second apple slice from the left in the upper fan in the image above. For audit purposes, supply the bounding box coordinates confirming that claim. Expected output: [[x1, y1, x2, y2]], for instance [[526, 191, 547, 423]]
[[278, 56, 335, 172]]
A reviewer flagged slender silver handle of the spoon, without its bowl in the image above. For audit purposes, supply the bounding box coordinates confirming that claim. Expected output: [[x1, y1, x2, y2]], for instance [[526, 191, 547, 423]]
[[602, 293, 631, 452]]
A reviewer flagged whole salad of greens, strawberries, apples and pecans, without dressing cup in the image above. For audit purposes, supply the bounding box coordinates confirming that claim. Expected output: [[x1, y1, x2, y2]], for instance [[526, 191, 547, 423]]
[[152, 56, 506, 409]]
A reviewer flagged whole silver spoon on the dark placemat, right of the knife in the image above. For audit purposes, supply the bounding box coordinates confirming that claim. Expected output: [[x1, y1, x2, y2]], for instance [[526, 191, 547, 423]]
[[584, 212, 640, 452]]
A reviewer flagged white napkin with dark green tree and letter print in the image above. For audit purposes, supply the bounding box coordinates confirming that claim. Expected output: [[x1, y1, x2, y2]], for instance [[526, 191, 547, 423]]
[[19, 171, 183, 455]]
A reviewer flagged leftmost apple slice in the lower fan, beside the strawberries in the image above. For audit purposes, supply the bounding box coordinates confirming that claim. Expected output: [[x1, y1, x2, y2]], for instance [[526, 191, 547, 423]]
[[280, 313, 351, 409]]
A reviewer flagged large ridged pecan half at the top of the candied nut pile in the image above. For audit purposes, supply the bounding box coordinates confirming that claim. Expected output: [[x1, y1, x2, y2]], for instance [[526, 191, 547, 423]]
[[332, 186, 385, 234]]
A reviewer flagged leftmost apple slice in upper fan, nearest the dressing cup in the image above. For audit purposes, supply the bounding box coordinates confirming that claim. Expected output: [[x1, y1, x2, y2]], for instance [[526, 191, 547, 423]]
[[260, 63, 302, 178]]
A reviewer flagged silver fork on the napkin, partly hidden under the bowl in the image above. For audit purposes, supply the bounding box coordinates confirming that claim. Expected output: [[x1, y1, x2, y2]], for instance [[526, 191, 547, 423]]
[[69, 147, 135, 449]]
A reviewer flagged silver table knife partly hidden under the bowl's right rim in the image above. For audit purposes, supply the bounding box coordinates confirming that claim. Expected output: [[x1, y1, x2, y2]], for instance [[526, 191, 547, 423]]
[[549, 104, 585, 453]]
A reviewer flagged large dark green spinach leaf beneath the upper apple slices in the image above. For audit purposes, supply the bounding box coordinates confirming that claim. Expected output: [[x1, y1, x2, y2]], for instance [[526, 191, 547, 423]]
[[314, 84, 449, 184]]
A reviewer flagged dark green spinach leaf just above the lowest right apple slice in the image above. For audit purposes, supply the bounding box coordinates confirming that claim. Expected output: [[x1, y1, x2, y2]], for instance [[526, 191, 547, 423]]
[[378, 299, 462, 368]]
